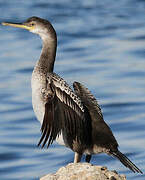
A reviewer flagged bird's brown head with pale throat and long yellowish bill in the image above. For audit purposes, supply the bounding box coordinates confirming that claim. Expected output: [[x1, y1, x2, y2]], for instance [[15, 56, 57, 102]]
[[2, 17, 56, 39]]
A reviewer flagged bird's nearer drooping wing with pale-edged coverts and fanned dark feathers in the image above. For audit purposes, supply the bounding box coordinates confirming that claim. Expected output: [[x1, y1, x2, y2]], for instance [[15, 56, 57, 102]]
[[38, 73, 91, 149]]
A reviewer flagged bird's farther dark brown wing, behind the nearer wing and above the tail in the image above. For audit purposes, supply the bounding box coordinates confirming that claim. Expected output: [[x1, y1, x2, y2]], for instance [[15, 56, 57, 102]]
[[73, 82, 118, 150]]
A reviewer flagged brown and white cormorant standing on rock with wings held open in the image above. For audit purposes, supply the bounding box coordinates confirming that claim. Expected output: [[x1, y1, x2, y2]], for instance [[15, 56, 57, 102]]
[[2, 16, 142, 173]]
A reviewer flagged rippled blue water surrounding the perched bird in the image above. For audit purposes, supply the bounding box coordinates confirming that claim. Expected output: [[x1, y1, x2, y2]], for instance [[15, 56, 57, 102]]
[[0, 0, 145, 180]]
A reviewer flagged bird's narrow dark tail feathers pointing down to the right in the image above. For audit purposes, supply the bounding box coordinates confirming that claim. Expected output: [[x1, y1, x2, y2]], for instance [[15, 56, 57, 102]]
[[111, 151, 143, 174]]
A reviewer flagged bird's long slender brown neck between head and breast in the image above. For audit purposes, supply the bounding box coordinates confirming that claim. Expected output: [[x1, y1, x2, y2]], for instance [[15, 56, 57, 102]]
[[36, 35, 57, 73]]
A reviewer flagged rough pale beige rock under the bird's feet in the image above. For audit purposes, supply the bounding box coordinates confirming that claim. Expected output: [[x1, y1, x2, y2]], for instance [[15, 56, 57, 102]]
[[40, 163, 126, 180]]
